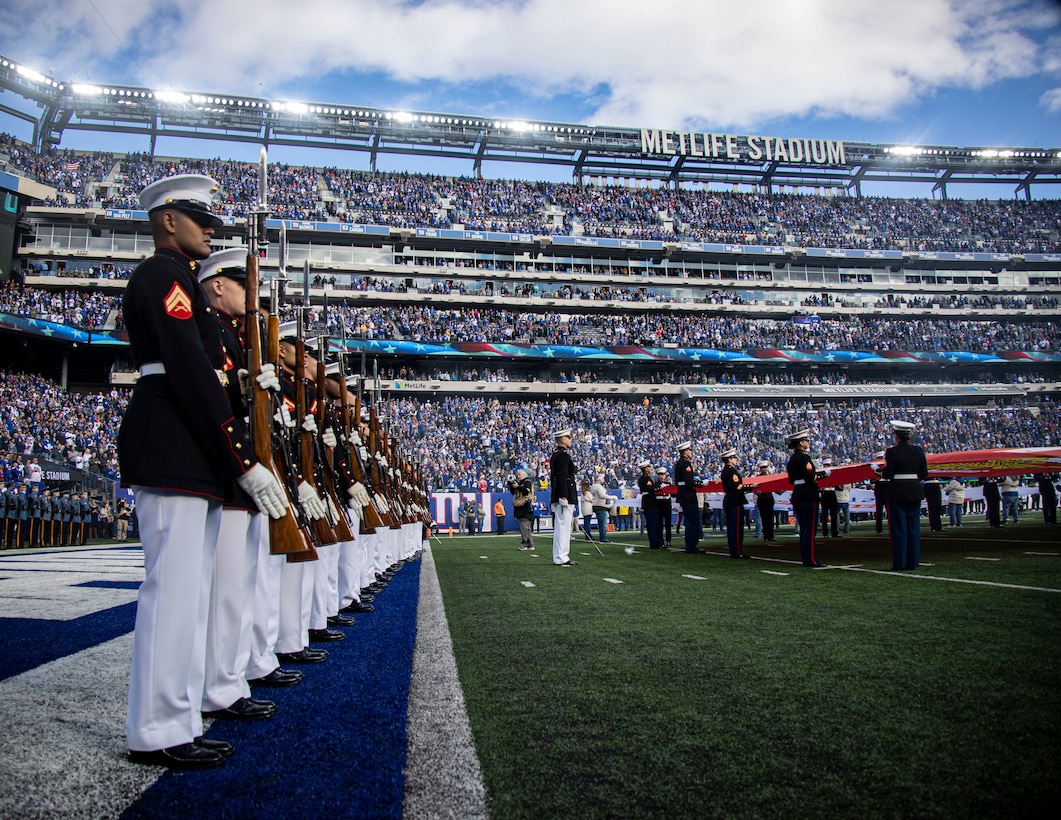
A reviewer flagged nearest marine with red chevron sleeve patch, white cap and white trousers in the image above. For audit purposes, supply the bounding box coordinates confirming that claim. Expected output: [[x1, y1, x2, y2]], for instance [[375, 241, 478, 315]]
[[118, 174, 286, 768]]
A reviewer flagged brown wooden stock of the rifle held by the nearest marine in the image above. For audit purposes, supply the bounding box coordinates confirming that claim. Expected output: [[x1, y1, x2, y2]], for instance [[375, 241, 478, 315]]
[[244, 254, 312, 555]]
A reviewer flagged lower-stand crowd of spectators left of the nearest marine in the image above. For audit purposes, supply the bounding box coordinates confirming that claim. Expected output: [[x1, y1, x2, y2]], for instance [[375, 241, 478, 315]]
[[0, 370, 128, 478]]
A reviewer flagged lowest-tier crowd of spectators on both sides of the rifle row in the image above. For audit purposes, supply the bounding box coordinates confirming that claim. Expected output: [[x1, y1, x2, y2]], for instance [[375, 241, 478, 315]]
[[0, 370, 1061, 489]]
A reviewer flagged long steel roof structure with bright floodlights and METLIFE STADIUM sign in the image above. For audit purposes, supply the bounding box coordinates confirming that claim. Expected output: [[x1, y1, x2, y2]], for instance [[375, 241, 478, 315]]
[[0, 56, 1061, 199]]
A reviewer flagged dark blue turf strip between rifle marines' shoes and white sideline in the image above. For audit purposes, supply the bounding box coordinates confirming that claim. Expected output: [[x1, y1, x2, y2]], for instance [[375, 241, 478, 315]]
[[122, 561, 420, 820]]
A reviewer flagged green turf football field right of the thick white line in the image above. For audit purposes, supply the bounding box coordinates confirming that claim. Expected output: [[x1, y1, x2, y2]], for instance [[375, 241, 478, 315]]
[[433, 516, 1061, 818]]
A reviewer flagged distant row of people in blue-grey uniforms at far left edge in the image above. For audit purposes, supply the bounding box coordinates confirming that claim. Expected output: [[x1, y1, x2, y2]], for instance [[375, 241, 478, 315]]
[[0, 484, 95, 549]]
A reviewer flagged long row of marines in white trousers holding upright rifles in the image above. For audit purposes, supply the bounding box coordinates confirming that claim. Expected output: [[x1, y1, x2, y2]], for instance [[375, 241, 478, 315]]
[[118, 169, 430, 769]]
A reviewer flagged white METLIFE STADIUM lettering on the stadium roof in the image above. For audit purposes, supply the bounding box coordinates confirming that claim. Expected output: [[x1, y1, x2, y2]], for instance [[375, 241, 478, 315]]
[[641, 128, 847, 165]]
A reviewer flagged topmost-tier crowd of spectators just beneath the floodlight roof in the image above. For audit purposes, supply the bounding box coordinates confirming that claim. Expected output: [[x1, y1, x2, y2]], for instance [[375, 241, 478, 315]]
[[0, 137, 1061, 254]]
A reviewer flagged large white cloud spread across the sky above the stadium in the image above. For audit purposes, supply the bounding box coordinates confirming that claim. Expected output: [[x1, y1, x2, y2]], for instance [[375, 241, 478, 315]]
[[0, 0, 1057, 128]]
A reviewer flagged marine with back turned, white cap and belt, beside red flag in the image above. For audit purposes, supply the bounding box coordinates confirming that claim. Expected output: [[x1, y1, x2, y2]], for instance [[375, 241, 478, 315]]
[[881, 420, 928, 570]]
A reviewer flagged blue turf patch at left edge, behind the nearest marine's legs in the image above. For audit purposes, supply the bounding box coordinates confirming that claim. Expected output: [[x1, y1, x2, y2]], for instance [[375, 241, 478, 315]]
[[0, 598, 136, 680]]
